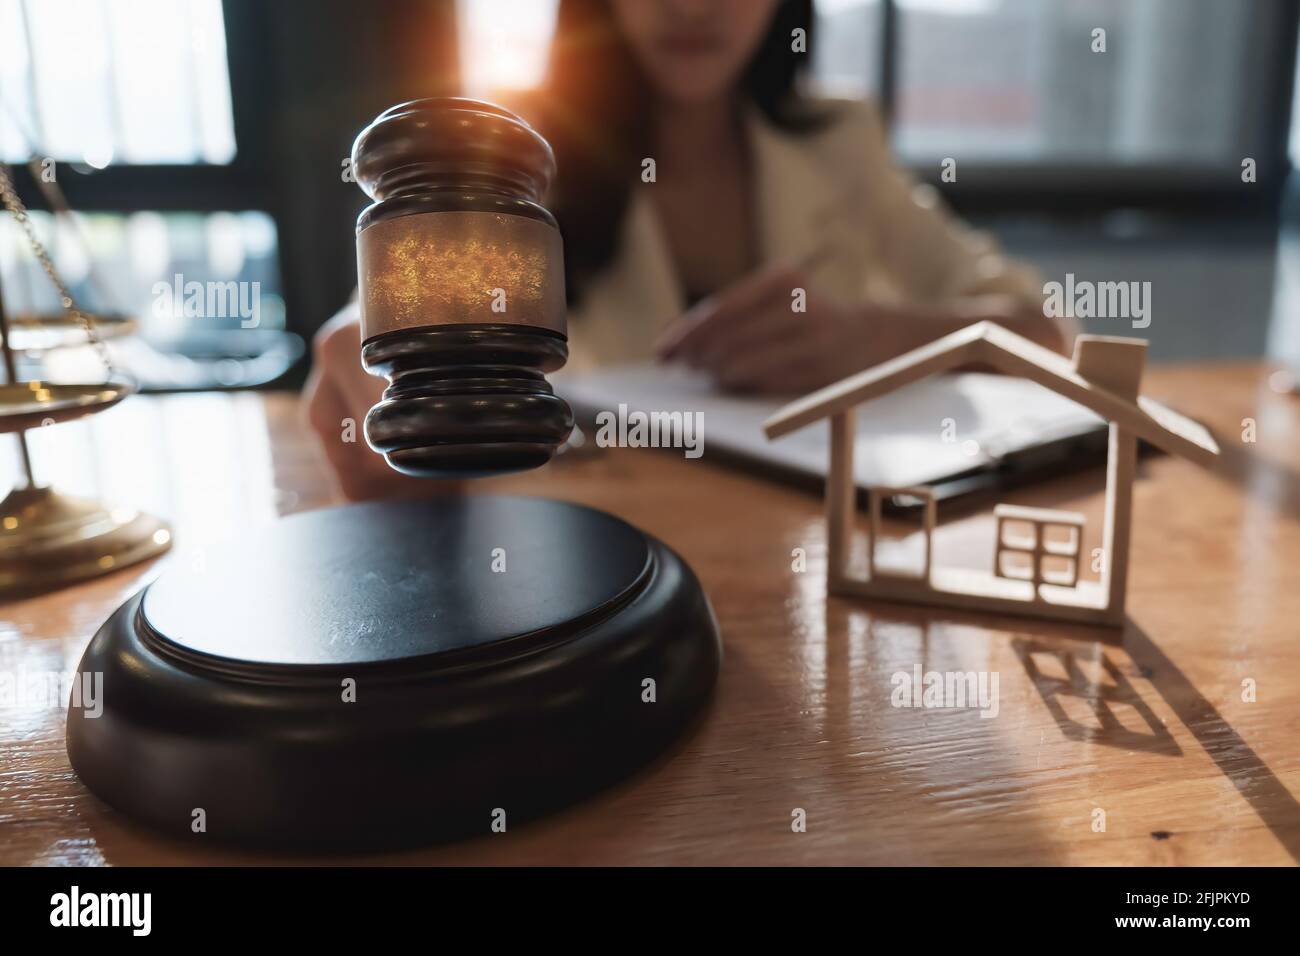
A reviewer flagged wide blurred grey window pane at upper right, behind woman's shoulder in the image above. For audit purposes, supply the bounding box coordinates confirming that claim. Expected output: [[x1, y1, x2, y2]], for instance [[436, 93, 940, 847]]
[[894, 0, 1284, 168]]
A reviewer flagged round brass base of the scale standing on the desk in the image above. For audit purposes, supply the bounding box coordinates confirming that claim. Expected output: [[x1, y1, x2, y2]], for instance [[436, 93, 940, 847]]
[[0, 486, 172, 597]]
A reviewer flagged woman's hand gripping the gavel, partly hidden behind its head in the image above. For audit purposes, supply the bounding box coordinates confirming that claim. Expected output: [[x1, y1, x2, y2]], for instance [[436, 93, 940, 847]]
[[303, 302, 447, 501]]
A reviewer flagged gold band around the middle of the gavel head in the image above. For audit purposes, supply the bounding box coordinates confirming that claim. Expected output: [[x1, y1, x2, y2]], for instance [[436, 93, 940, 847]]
[[356, 212, 566, 342]]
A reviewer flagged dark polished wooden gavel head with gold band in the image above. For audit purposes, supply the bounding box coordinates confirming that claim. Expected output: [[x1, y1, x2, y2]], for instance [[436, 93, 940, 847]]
[[352, 98, 573, 477]]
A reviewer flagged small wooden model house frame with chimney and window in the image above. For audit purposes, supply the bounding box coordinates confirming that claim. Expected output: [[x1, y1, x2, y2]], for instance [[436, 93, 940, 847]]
[[764, 323, 1218, 624]]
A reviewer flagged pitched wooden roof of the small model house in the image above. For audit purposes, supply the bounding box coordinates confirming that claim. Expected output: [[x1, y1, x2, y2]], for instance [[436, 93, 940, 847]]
[[763, 323, 1218, 464]]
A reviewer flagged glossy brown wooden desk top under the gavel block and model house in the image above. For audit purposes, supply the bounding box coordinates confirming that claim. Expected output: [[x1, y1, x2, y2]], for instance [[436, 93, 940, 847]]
[[0, 365, 1300, 865]]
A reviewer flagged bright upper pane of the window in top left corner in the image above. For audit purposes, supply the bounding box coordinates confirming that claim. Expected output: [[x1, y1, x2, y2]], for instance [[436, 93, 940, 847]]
[[0, 0, 235, 169]]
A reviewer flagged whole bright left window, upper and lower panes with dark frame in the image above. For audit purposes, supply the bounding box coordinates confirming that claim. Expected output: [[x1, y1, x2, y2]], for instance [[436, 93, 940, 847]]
[[0, 0, 295, 389]]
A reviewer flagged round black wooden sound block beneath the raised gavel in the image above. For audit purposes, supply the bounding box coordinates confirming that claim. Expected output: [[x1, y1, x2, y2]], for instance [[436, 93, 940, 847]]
[[68, 496, 722, 849]]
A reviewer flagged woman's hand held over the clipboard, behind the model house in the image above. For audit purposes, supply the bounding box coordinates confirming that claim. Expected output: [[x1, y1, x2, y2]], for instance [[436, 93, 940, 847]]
[[658, 268, 897, 394]]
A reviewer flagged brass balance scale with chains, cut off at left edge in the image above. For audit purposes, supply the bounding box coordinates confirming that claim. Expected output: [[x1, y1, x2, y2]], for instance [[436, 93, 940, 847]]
[[0, 164, 172, 600]]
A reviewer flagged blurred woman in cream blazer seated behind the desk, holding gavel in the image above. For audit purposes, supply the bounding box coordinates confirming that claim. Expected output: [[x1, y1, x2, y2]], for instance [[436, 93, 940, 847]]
[[307, 0, 1069, 497]]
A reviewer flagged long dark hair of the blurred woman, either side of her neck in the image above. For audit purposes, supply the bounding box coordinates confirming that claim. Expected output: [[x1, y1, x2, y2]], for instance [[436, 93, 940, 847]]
[[530, 0, 822, 303]]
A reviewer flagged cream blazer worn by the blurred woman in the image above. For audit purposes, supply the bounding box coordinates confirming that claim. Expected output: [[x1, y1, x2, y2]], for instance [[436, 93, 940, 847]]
[[569, 100, 1043, 371]]
